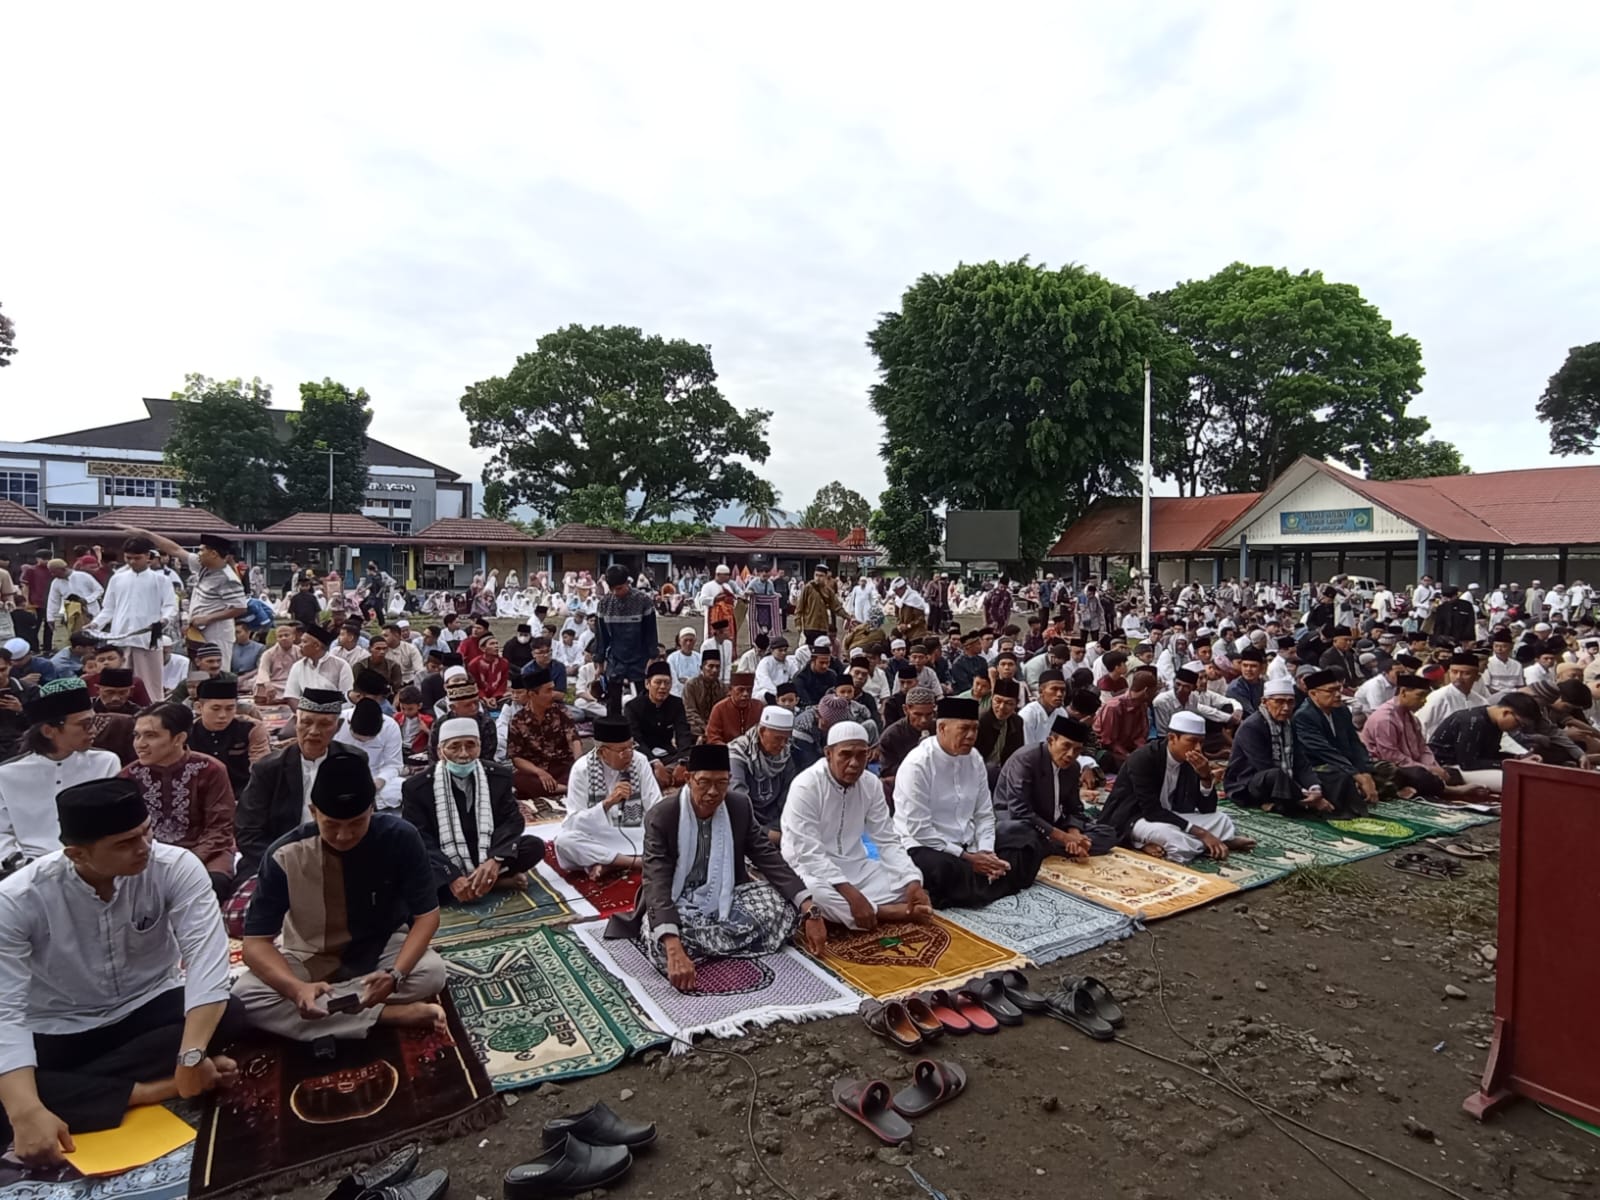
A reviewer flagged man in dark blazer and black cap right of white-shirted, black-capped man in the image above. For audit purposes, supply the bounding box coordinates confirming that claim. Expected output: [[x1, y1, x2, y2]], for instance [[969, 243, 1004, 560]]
[[995, 712, 1117, 862]]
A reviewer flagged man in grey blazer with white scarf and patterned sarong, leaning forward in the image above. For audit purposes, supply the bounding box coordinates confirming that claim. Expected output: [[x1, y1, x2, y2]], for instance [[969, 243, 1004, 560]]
[[606, 744, 827, 992]]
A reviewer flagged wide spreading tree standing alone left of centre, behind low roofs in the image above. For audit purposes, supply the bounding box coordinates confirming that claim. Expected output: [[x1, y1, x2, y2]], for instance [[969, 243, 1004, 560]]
[[461, 325, 776, 522]]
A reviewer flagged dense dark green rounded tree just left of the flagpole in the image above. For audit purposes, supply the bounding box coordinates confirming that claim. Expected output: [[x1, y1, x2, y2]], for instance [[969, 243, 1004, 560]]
[[867, 259, 1170, 562]]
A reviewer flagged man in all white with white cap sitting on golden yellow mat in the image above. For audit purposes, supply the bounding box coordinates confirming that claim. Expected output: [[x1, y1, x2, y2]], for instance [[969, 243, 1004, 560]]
[[780, 718, 933, 930]]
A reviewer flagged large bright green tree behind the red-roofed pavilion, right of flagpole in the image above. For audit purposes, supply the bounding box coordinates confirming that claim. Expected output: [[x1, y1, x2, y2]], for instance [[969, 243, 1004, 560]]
[[1150, 262, 1429, 494]]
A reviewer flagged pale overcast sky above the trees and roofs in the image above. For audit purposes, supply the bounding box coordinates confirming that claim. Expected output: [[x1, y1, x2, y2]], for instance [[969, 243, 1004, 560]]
[[0, 0, 1600, 509]]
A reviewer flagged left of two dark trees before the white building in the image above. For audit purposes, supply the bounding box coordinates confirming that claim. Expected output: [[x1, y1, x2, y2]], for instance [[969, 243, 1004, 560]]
[[163, 374, 283, 528]]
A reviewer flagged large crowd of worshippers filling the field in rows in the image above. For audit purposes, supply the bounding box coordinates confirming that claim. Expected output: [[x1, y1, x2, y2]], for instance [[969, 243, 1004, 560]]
[[0, 531, 1600, 1162]]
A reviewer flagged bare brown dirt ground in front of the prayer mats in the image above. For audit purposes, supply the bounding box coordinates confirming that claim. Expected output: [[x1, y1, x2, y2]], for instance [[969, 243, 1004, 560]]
[[296, 826, 1600, 1200]]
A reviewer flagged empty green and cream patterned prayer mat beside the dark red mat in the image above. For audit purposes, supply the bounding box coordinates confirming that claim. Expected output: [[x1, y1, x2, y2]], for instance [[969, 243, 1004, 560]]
[[438, 928, 666, 1091]]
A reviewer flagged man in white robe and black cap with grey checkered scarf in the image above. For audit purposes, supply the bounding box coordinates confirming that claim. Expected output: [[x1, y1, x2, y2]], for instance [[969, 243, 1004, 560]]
[[555, 717, 661, 878]]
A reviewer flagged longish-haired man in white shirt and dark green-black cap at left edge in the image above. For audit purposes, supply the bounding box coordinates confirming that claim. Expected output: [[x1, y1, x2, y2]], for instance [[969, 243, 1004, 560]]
[[0, 675, 122, 862]]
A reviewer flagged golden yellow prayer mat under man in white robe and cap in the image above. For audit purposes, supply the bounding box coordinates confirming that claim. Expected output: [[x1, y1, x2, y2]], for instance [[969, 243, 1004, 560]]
[[821, 917, 1027, 1000]]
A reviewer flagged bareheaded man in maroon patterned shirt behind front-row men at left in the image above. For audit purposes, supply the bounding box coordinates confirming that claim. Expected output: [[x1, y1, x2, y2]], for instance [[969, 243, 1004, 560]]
[[122, 702, 234, 899]]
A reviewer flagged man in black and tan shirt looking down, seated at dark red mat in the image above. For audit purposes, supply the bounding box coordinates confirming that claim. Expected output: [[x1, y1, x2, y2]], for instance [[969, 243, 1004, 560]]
[[234, 754, 445, 1042]]
